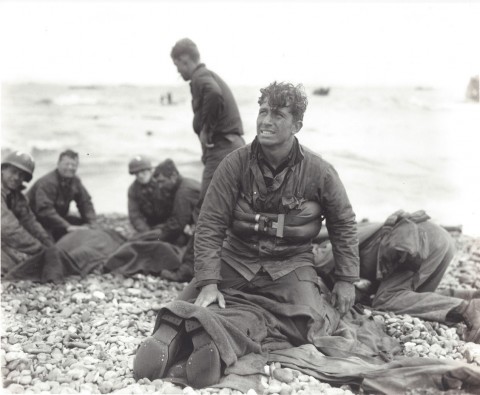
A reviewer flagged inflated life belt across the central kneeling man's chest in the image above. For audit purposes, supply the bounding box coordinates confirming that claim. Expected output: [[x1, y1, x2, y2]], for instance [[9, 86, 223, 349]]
[[231, 198, 323, 241]]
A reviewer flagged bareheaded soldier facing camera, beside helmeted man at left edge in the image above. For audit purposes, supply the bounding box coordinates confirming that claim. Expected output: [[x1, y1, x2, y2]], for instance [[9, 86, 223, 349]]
[[27, 150, 96, 240]]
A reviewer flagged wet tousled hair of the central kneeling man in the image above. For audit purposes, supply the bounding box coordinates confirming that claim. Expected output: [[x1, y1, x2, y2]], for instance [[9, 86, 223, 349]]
[[258, 81, 308, 121]]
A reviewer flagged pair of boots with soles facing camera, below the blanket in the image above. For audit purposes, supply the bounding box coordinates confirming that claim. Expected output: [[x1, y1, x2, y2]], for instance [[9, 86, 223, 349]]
[[133, 312, 222, 388]]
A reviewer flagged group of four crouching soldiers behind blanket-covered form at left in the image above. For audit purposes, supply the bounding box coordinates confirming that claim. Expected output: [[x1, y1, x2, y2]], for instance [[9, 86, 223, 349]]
[[1, 150, 200, 281]]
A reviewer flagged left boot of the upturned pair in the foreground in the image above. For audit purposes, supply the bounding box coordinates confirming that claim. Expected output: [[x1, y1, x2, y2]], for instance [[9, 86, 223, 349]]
[[133, 313, 186, 380]]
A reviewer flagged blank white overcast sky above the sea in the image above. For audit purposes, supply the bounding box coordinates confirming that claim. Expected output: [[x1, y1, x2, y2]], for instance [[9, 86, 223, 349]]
[[0, 0, 480, 89]]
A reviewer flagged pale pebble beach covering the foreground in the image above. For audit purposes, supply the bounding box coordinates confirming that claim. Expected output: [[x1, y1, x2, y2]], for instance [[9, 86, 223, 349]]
[[0, 215, 480, 395]]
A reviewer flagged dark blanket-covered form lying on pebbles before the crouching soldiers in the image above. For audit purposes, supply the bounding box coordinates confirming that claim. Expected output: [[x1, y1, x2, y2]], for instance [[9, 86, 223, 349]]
[[5, 229, 182, 282]]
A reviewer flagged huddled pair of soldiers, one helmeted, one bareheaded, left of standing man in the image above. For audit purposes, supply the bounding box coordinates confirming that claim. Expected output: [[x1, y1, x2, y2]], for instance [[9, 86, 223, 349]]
[[128, 156, 200, 244]]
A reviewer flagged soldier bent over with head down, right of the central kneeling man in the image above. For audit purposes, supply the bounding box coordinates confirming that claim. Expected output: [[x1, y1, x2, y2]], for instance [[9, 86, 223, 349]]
[[315, 210, 480, 343]]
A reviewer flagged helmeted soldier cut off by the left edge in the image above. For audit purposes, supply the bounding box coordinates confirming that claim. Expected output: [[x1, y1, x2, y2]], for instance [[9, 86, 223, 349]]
[[1, 151, 54, 275]]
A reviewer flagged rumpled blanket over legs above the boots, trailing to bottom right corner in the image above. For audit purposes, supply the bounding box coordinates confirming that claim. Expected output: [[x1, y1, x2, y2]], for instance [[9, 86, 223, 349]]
[[154, 290, 480, 394]]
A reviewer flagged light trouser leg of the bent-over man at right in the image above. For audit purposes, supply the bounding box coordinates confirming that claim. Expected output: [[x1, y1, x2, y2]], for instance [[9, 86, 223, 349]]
[[372, 222, 462, 322]]
